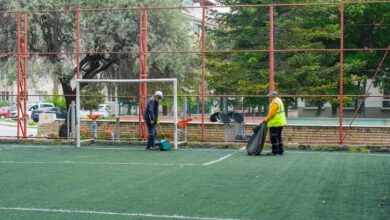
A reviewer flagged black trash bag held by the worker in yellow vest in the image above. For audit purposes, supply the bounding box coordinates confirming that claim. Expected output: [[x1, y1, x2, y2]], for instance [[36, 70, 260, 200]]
[[246, 122, 268, 156]]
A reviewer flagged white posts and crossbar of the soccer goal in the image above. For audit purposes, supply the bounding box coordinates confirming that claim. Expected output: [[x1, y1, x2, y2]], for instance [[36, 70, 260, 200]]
[[76, 78, 179, 150]]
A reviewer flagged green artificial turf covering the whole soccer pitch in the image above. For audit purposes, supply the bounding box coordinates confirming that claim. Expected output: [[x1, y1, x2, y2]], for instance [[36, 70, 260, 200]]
[[0, 145, 390, 219]]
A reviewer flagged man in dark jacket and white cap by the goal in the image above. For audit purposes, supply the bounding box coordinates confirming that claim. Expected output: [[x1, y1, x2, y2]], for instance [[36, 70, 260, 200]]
[[144, 91, 164, 150]]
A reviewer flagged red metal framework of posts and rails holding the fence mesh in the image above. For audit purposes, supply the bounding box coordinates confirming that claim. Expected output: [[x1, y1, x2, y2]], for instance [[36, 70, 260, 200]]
[[0, 3, 389, 144]]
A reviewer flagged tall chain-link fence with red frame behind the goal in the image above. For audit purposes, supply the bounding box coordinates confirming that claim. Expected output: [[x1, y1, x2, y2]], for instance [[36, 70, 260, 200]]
[[0, 1, 390, 144]]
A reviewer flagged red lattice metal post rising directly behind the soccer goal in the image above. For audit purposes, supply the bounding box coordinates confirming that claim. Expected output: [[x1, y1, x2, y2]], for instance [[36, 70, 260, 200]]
[[138, 9, 148, 139]]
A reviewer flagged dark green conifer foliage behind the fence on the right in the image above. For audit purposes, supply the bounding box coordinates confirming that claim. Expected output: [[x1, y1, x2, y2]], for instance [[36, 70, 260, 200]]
[[208, 0, 390, 115]]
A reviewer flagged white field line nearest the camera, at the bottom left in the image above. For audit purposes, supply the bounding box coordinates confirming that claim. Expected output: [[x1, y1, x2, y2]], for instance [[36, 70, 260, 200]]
[[0, 207, 242, 220]]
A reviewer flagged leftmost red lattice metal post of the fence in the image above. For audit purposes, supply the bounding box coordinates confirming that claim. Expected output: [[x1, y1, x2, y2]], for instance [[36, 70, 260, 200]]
[[16, 12, 28, 139]]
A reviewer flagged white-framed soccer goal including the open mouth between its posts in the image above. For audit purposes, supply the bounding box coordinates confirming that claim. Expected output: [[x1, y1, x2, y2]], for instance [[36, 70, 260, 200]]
[[75, 78, 179, 149]]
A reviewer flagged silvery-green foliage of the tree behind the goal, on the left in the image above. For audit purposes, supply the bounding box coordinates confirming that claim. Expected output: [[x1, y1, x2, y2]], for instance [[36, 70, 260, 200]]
[[0, 0, 192, 109]]
